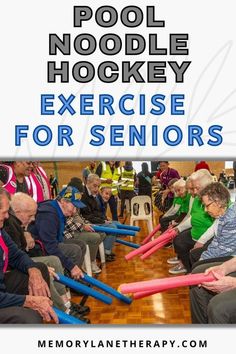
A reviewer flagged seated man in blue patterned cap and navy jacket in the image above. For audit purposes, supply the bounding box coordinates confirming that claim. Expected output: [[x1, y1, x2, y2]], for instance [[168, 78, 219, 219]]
[[29, 187, 86, 279]]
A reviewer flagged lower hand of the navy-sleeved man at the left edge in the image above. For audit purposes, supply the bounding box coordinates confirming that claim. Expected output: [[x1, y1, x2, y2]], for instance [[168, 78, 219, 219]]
[[23, 295, 59, 323]]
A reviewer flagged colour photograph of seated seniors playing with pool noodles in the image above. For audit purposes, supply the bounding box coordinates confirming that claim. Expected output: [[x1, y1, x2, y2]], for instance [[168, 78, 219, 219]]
[[0, 160, 236, 326]]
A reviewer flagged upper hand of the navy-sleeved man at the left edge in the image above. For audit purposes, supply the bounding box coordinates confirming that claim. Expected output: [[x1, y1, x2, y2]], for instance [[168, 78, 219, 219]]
[[28, 268, 51, 297]]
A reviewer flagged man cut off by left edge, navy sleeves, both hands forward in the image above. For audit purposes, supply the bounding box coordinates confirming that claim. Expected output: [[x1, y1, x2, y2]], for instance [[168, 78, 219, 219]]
[[0, 188, 58, 323]]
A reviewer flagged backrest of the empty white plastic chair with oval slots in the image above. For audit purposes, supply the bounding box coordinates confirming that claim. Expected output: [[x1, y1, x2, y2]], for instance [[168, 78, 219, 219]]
[[131, 195, 152, 219]]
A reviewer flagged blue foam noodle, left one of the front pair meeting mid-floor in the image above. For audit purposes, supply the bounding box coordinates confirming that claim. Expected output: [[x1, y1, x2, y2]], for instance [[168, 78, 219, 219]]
[[55, 273, 112, 305]]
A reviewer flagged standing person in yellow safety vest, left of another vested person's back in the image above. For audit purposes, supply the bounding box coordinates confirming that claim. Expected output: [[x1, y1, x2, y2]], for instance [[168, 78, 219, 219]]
[[96, 161, 121, 221]]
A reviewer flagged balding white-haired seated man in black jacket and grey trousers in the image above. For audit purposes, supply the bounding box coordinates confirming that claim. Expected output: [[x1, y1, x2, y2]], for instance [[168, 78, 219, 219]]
[[4, 192, 89, 320]]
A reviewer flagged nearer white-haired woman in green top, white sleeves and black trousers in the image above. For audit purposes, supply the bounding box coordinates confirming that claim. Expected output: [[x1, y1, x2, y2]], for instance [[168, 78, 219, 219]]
[[169, 170, 214, 274]]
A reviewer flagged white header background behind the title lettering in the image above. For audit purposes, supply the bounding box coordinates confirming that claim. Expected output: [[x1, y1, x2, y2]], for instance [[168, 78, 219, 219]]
[[0, 0, 236, 160]]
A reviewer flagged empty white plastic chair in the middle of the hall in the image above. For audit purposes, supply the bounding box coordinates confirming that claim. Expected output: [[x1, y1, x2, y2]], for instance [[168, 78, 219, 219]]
[[130, 195, 153, 233]]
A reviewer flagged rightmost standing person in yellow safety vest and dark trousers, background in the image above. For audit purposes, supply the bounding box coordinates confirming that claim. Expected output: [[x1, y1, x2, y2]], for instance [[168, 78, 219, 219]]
[[119, 161, 136, 217]]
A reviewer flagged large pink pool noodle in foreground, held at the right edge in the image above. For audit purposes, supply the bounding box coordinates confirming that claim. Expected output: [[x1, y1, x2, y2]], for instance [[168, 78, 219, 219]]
[[120, 273, 215, 296]]
